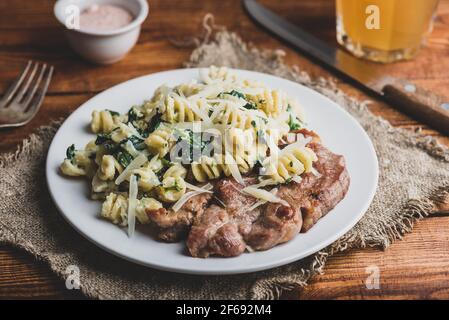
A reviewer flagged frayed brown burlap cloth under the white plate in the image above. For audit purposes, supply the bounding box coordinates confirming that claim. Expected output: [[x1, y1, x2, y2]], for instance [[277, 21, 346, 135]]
[[0, 32, 449, 299]]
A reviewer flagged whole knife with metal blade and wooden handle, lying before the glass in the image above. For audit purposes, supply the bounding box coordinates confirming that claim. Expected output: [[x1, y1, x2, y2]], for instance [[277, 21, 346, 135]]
[[244, 0, 449, 135]]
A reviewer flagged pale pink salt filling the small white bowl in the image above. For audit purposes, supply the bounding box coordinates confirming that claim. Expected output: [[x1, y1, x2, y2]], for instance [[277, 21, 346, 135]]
[[80, 4, 134, 31]]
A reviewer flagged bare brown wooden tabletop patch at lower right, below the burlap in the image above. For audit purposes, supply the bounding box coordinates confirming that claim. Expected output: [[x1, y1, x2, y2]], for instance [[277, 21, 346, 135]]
[[300, 218, 449, 299]]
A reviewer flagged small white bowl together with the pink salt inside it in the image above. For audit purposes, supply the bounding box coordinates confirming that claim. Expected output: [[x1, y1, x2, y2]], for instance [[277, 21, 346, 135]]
[[54, 0, 149, 64]]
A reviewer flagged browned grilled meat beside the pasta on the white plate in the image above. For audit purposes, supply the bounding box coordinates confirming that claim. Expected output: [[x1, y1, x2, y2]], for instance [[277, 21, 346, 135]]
[[187, 142, 349, 257]]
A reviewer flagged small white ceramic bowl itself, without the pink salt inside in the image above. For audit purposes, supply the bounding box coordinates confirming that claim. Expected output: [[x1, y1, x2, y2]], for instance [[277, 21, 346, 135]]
[[54, 0, 148, 64]]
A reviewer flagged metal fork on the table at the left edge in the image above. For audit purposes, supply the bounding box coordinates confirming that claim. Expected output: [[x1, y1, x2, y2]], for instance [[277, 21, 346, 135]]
[[0, 60, 53, 128]]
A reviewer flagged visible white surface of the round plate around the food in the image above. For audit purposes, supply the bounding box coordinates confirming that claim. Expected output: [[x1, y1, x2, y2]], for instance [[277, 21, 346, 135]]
[[46, 69, 378, 274]]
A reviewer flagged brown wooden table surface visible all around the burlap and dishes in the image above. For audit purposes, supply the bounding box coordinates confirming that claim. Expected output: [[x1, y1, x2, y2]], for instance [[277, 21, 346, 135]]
[[0, 0, 449, 299]]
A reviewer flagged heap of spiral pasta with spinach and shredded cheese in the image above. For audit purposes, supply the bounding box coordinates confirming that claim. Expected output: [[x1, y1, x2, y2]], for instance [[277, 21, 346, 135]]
[[60, 66, 316, 239]]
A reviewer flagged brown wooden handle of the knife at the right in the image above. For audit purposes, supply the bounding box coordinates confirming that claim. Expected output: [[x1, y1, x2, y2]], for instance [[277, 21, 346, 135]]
[[382, 79, 449, 135]]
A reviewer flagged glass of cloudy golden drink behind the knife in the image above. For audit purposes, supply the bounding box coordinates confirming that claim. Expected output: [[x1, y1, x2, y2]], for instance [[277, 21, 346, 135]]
[[337, 0, 438, 62]]
